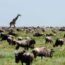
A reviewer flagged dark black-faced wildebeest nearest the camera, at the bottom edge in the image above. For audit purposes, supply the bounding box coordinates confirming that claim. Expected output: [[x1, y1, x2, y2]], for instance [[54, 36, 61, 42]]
[[15, 51, 34, 65]]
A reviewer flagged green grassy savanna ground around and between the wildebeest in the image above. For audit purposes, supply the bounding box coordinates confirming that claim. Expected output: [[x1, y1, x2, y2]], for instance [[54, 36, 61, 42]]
[[0, 27, 65, 65]]
